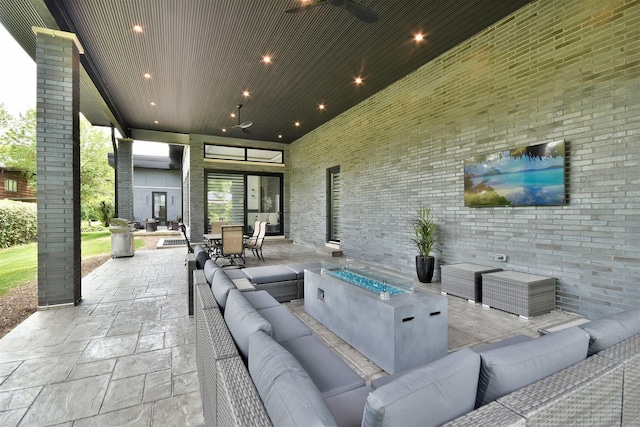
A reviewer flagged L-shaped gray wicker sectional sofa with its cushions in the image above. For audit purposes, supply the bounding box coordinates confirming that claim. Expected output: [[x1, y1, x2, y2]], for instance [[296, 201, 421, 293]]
[[193, 261, 640, 426]]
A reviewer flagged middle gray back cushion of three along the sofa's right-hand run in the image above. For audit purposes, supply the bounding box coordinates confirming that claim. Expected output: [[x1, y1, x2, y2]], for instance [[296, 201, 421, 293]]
[[476, 326, 589, 407]]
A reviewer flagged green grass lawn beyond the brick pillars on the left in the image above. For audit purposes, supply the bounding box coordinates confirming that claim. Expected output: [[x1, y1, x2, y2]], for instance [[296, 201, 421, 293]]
[[0, 231, 144, 295]]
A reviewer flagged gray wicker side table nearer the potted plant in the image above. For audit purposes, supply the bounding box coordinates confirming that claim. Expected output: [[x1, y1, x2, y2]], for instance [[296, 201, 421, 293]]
[[440, 263, 502, 303]]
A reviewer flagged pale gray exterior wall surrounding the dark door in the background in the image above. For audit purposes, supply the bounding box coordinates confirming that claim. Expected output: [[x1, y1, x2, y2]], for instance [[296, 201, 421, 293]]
[[133, 167, 182, 225]]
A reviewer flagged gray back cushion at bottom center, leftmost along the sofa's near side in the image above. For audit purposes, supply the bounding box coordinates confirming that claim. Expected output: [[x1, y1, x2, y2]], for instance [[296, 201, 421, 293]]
[[362, 349, 480, 427]]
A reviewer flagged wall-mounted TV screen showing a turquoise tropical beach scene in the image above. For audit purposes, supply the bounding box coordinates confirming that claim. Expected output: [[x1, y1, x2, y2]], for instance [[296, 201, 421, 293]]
[[464, 141, 566, 207]]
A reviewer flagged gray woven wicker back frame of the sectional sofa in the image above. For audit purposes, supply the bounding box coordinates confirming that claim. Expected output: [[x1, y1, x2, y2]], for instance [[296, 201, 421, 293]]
[[193, 256, 640, 426]]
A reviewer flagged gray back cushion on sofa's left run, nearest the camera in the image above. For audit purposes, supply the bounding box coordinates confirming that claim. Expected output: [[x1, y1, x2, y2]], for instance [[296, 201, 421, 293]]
[[249, 332, 337, 426]]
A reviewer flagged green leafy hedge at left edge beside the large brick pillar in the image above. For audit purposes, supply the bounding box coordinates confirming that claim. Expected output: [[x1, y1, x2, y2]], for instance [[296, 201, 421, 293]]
[[0, 200, 38, 248]]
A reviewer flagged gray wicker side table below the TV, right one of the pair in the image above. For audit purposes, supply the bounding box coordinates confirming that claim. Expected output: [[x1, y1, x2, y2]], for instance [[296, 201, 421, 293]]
[[482, 271, 556, 319]]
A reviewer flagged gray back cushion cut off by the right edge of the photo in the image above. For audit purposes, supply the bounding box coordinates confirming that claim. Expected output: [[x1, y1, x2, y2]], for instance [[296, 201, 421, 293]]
[[579, 309, 640, 355]]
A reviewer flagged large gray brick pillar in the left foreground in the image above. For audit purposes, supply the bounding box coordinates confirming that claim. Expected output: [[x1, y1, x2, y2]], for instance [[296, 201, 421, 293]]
[[33, 28, 82, 308]]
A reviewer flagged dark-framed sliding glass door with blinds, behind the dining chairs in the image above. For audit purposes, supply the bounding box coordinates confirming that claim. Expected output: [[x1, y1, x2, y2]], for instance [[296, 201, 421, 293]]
[[207, 172, 284, 235]]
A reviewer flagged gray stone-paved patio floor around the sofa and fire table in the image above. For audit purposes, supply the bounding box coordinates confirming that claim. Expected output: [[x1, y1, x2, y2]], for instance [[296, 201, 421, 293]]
[[0, 242, 577, 426]]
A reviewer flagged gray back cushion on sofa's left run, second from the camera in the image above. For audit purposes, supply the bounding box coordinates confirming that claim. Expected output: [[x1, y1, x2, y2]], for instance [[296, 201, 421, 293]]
[[224, 289, 272, 359]]
